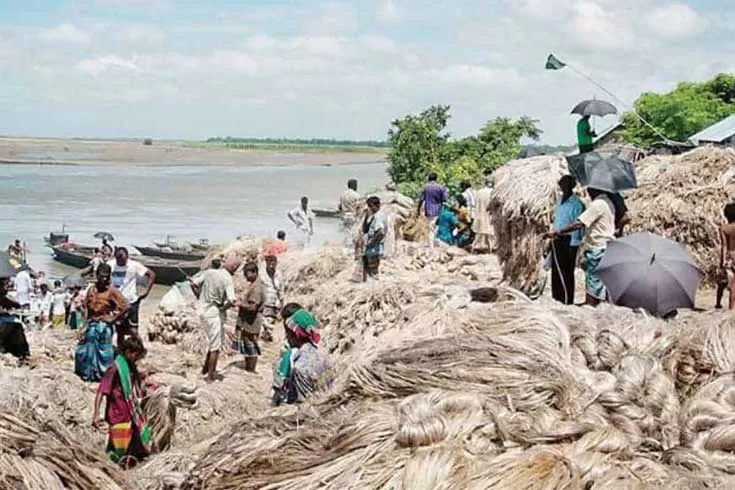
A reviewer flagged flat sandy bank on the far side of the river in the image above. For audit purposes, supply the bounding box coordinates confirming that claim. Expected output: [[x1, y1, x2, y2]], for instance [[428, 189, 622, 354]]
[[0, 138, 385, 166]]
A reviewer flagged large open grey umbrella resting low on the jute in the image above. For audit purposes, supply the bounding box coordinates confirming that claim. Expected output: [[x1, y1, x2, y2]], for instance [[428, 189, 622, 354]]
[[595, 232, 704, 316]]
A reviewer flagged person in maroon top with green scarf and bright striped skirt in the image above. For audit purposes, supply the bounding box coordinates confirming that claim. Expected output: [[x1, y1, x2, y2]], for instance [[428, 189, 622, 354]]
[[92, 336, 152, 469]]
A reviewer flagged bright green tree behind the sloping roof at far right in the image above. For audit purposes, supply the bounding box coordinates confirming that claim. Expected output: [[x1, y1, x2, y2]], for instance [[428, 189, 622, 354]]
[[621, 74, 735, 148]]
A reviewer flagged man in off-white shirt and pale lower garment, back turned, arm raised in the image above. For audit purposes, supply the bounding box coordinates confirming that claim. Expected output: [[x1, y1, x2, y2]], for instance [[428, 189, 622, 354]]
[[190, 259, 240, 383]]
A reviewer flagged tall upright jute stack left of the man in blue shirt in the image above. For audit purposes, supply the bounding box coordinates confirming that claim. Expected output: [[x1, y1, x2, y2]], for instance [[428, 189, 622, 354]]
[[490, 155, 568, 292]]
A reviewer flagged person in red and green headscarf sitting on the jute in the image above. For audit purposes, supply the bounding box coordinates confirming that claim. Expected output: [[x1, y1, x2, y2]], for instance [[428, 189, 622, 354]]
[[273, 303, 334, 405]]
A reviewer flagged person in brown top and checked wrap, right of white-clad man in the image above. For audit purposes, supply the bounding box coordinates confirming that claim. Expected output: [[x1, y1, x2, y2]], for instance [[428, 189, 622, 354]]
[[237, 262, 263, 373]]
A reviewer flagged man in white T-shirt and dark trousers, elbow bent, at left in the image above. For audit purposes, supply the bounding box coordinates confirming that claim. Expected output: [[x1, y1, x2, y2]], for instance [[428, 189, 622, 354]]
[[108, 247, 156, 348]]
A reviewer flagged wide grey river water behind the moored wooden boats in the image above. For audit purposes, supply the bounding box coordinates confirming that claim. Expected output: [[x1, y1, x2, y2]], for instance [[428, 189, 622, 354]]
[[0, 163, 388, 276]]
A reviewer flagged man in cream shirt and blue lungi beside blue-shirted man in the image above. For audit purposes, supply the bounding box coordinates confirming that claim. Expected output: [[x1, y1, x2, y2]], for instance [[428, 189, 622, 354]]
[[547, 188, 615, 306]]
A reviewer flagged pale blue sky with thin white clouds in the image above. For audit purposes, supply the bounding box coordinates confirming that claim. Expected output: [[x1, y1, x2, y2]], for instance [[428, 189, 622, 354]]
[[0, 0, 735, 144]]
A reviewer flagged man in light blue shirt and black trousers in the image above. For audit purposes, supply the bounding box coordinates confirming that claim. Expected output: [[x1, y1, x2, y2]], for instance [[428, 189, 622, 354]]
[[551, 175, 584, 305]]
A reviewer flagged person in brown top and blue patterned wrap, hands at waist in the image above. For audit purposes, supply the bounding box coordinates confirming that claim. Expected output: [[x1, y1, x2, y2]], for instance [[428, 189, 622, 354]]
[[74, 264, 128, 381]]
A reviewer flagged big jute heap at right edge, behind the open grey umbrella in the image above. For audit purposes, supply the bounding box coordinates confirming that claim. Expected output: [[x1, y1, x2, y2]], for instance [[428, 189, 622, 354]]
[[626, 146, 735, 283]]
